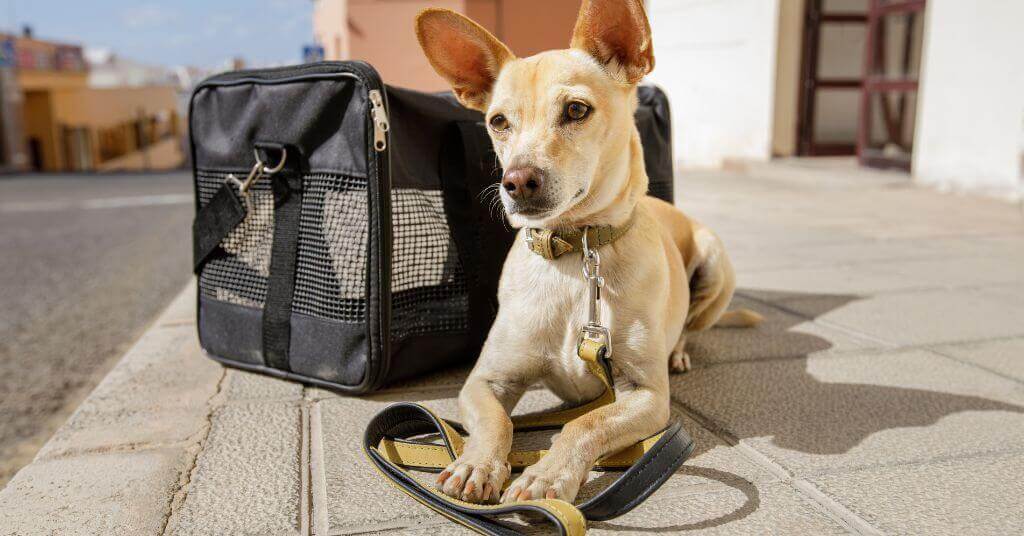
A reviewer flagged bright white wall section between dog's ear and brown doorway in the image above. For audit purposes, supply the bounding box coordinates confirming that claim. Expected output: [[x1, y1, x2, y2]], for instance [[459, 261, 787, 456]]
[[647, 0, 778, 167]]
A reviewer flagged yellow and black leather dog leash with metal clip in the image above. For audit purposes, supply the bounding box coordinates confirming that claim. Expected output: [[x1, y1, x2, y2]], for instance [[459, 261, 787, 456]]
[[362, 229, 694, 536]]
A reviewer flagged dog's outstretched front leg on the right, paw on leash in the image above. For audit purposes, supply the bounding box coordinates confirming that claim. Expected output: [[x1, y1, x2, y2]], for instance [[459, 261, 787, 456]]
[[502, 344, 669, 502]]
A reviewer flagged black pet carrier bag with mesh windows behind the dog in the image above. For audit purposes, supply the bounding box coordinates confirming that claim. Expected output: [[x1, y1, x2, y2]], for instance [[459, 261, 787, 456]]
[[189, 61, 672, 393]]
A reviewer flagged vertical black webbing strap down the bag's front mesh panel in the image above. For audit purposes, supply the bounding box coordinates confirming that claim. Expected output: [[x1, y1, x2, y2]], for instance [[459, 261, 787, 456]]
[[263, 169, 302, 371]]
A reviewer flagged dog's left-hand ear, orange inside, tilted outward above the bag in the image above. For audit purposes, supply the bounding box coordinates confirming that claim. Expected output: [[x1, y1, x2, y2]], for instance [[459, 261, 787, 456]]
[[416, 8, 515, 112]]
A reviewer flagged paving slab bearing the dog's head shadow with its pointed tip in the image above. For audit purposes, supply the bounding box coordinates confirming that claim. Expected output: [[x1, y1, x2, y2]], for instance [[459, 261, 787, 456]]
[[673, 349, 1024, 476]]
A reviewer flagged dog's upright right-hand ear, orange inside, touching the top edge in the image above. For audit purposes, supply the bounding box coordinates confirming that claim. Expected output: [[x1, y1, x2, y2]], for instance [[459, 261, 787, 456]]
[[570, 0, 654, 84]]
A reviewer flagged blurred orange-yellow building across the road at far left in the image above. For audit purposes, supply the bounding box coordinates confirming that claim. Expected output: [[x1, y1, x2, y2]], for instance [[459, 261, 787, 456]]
[[0, 35, 182, 171]]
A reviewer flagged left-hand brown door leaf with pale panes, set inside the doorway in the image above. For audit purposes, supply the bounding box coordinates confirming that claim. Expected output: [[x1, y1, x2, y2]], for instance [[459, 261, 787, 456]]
[[797, 0, 870, 156]]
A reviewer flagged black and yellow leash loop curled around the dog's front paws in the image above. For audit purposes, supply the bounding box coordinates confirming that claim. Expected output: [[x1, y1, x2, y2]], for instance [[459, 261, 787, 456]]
[[364, 403, 693, 536]]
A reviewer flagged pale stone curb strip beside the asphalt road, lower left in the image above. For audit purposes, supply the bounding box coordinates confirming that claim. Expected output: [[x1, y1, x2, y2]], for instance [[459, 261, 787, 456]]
[[0, 280, 225, 535]]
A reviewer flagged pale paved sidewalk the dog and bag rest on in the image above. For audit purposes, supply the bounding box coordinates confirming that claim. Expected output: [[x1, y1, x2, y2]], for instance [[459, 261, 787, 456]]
[[0, 163, 1024, 536]]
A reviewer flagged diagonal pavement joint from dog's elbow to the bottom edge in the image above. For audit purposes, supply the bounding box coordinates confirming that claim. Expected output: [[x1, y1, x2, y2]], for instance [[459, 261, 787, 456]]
[[672, 401, 883, 536]]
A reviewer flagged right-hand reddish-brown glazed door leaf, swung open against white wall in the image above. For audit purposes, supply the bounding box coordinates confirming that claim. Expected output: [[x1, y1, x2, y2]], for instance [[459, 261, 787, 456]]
[[857, 0, 926, 170]]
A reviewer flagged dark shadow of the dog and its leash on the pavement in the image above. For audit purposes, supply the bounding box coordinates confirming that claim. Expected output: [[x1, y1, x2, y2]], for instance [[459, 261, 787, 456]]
[[582, 290, 1024, 533]]
